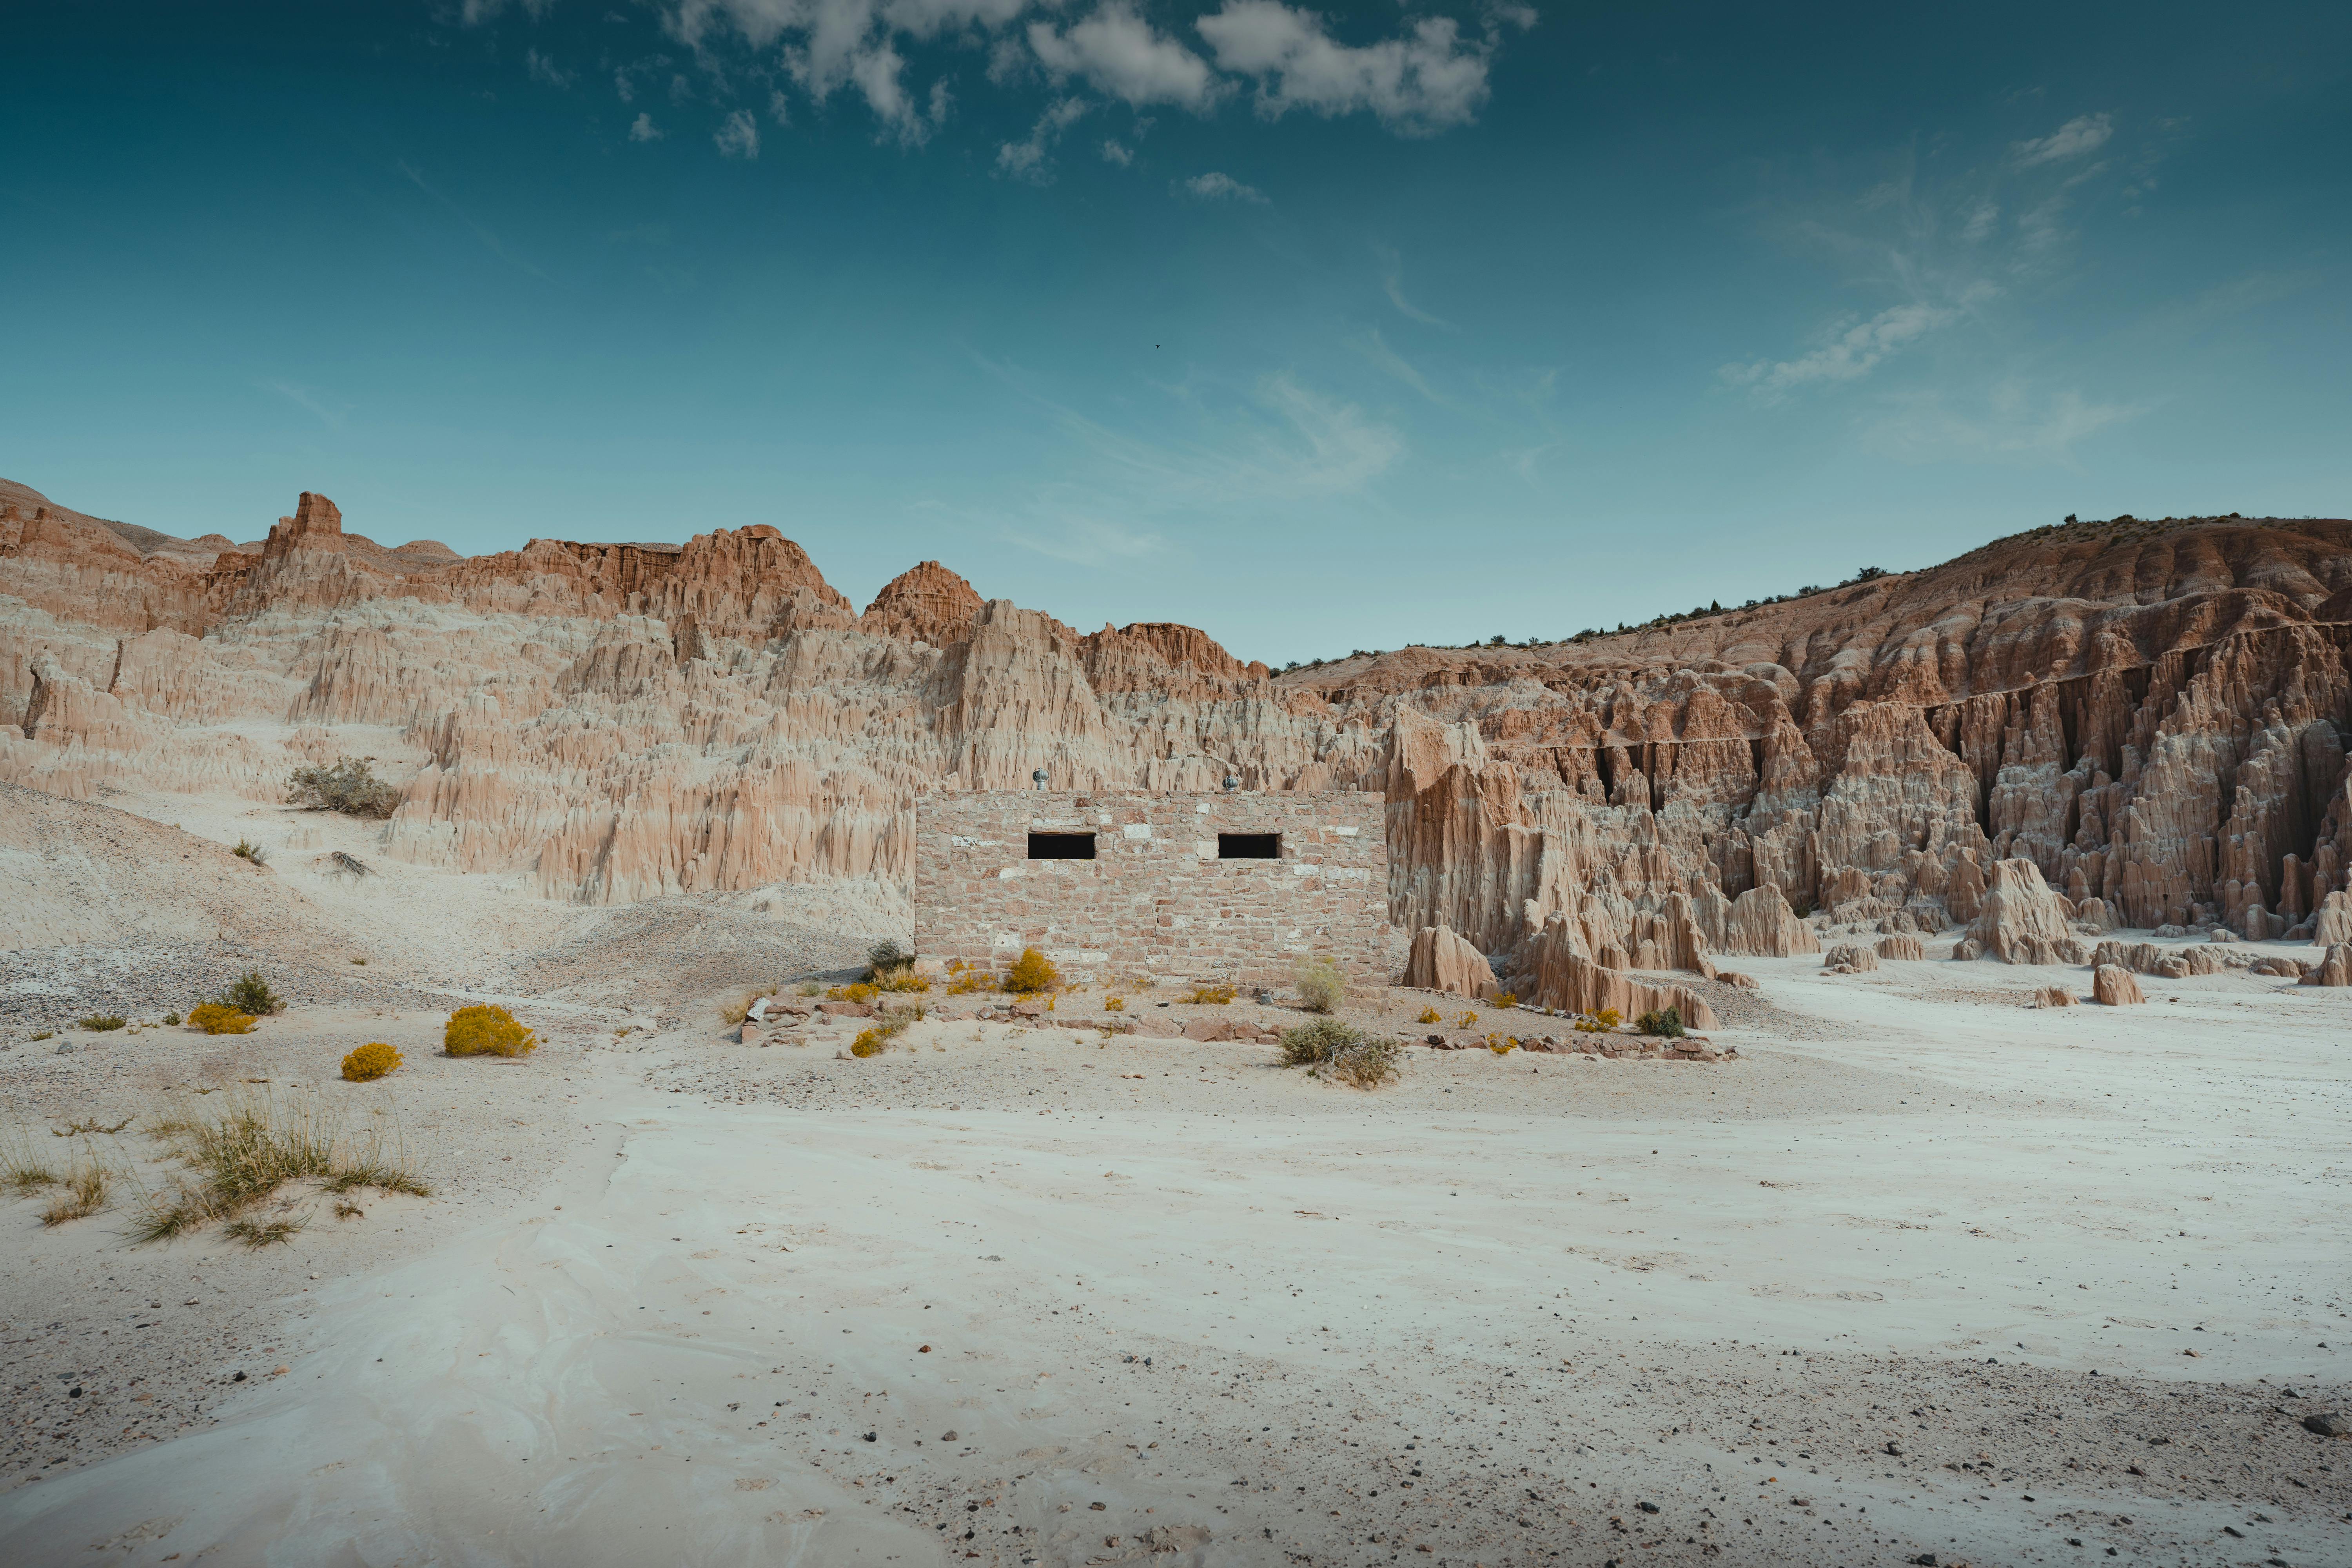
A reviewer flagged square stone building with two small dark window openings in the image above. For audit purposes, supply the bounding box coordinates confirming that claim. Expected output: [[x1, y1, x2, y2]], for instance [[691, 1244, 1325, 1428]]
[[915, 790, 1395, 985]]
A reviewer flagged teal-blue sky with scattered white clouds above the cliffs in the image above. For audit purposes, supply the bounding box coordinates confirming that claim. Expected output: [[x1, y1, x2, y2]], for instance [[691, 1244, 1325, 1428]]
[[0, 0, 2352, 665]]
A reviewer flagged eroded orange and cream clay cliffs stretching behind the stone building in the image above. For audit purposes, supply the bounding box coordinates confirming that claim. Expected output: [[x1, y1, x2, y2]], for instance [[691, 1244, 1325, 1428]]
[[0, 484, 2352, 990]]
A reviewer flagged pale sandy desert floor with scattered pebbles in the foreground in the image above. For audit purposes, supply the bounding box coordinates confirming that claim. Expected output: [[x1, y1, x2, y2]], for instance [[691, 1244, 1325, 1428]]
[[0, 818, 2352, 1568]]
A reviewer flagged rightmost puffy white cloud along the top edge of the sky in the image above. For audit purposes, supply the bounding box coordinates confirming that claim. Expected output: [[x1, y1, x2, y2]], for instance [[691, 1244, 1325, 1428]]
[[1192, 0, 1534, 134]]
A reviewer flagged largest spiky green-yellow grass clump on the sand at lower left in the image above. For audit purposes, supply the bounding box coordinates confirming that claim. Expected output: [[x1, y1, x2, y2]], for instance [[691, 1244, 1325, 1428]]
[[134, 1093, 430, 1246]]
